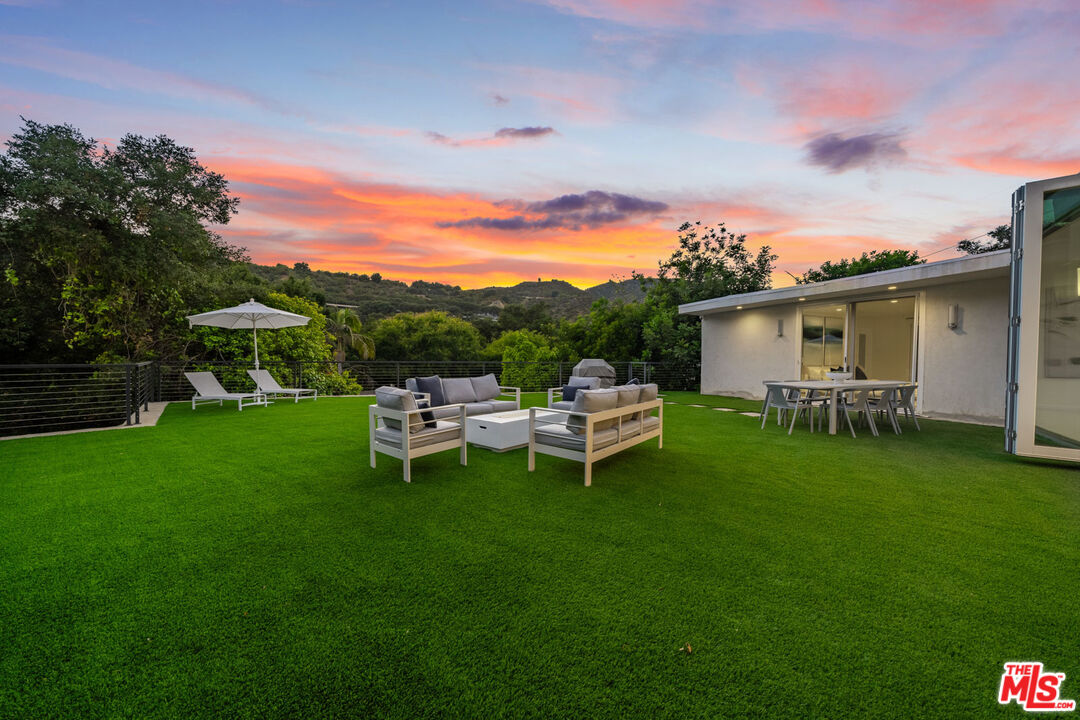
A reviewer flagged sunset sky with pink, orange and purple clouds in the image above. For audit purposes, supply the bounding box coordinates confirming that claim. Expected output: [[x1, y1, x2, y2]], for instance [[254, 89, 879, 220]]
[[0, 0, 1080, 288]]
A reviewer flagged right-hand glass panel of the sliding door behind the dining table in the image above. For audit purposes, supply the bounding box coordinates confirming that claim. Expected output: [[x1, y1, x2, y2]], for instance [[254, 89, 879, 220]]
[[849, 297, 916, 381]]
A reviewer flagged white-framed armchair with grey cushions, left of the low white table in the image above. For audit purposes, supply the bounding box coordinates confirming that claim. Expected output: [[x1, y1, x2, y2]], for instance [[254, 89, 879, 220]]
[[367, 386, 468, 483]]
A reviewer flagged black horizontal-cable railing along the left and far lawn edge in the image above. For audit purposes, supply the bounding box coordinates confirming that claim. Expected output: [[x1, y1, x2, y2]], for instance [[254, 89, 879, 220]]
[[0, 359, 701, 436]]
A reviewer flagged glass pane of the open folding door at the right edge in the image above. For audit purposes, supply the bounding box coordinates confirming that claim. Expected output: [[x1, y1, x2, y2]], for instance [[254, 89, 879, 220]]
[[1025, 187, 1080, 448]]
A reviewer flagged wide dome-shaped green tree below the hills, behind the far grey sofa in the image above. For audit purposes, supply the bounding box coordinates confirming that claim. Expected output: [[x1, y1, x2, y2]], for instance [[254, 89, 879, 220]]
[[372, 311, 482, 361]]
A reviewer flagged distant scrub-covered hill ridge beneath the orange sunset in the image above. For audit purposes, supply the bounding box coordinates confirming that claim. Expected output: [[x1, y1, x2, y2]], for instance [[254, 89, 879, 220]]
[[251, 263, 645, 320]]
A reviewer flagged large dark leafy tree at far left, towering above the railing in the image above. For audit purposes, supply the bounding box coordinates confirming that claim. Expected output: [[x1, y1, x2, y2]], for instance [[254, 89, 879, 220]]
[[0, 120, 244, 362]]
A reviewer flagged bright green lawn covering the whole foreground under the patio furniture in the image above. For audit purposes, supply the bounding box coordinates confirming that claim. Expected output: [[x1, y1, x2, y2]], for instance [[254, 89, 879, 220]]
[[0, 393, 1080, 719]]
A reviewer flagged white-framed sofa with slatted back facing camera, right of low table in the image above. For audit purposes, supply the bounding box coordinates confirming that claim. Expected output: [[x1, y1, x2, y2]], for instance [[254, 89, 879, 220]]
[[529, 383, 664, 487]]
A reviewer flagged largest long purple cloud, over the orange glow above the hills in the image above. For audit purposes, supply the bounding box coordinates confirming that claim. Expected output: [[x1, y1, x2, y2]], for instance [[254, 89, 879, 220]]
[[435, 190, 667, 231]]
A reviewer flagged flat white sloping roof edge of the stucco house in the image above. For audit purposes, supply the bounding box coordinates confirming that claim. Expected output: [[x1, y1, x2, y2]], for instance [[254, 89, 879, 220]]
[[678, 250, 1011, 315]]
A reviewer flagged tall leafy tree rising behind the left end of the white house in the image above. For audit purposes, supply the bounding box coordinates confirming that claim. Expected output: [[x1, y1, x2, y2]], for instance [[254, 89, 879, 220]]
[[635, 221, 777, 363]]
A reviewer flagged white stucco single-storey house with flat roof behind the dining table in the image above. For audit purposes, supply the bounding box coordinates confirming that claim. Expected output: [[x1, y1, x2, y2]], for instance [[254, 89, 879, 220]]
[[679, 250, 1011, 424]]
